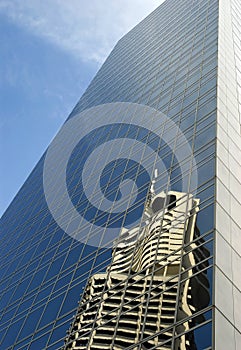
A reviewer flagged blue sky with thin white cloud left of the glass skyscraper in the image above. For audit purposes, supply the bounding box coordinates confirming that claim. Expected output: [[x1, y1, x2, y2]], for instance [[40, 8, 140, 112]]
[[0, 0, 163, 215]]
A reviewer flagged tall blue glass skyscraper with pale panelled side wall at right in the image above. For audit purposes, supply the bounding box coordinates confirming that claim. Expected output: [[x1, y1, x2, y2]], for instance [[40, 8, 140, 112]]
[[0, 0, 241, 350]]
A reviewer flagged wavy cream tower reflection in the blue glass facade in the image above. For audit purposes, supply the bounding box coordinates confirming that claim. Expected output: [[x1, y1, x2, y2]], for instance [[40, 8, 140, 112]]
[[66, 192, 209, 349]]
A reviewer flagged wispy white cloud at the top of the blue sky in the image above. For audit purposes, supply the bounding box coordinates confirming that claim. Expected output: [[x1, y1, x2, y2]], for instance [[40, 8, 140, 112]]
[[0, 0, 164, 63]]
